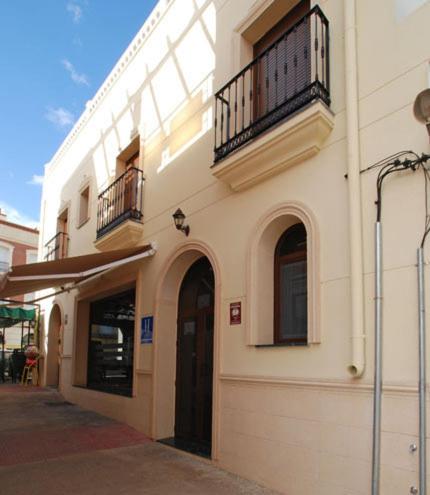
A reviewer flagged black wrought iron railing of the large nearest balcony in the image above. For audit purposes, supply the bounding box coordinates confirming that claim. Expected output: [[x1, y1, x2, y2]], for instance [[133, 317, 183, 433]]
[[214, 6, 330, 163]]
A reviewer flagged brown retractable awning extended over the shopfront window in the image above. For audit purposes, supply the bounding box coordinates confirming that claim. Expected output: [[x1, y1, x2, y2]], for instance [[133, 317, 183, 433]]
[[0, 244, 155, 298]]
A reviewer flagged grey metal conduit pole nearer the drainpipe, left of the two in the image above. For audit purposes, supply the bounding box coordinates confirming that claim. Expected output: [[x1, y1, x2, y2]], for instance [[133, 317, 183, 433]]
[[372, 222, 382, 495]]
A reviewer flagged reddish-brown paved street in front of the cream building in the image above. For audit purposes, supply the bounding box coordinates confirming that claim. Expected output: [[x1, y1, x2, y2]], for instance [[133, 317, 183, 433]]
[[0, 385, 274, 495]]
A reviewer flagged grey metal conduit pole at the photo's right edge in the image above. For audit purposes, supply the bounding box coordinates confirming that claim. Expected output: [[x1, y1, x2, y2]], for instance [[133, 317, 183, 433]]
[[417, 247, 427, 495]]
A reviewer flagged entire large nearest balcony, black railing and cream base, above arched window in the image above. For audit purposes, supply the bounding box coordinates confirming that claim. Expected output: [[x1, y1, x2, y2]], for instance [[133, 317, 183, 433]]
[[212, 6, 334, 190]]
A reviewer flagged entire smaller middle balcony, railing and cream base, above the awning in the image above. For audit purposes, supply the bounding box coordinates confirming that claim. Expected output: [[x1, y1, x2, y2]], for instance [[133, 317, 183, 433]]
[[95, 167, 144, 251]]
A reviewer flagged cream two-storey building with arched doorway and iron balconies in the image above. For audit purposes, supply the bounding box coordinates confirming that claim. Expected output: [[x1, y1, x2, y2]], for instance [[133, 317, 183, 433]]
[[4, 0, 430, 495]]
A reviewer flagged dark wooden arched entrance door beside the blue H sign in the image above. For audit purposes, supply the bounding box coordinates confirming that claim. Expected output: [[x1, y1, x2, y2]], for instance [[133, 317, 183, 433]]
[[175, 258, 214, 454]]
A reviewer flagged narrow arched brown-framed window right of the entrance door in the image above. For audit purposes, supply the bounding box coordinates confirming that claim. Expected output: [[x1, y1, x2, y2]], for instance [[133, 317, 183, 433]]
[[273, 223, 308, 345]]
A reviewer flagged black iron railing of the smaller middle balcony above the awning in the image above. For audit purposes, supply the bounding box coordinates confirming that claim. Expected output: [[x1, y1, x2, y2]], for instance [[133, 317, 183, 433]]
[[97, 167, 144, 239]]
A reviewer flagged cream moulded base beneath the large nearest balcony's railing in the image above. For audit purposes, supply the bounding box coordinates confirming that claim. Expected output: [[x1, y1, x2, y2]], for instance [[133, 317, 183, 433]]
[[212, 101, 334, 191]]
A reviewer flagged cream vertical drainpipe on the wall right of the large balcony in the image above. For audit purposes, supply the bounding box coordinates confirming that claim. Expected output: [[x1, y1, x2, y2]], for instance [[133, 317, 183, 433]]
[[344, 0, 365, 378]]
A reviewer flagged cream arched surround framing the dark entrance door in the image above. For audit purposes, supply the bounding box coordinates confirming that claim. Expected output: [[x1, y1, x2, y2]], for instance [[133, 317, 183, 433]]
[[152, 241, 221, 460]]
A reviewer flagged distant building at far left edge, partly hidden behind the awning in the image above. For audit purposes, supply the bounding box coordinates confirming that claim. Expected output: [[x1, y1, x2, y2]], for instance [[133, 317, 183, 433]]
[[0, 210, 39, 350]]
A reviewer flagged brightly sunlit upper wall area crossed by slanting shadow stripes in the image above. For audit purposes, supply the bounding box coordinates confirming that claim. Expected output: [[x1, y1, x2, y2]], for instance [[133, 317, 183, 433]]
[[43, 0, 216, 254]]
